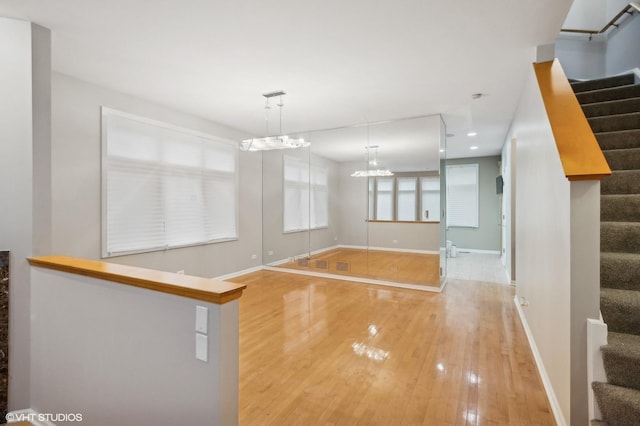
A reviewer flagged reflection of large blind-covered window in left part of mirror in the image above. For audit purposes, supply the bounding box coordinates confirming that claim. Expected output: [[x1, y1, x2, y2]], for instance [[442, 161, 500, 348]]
[[283, 156, 329, 232]]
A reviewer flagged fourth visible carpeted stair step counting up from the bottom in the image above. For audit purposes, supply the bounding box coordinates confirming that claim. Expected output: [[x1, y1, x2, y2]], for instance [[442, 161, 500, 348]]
[[600, 252, 640, 291]]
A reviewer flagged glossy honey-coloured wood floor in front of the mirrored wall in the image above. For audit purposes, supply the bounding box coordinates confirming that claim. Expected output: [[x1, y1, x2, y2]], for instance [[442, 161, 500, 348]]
[[232, 271, 555, 425]]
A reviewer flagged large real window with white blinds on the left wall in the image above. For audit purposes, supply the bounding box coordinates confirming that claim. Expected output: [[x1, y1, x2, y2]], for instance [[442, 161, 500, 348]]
[[102, 108, 238, 257]]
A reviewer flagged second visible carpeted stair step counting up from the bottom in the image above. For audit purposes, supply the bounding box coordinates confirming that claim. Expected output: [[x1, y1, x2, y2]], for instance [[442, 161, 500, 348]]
[[601, 333, 640, 390]]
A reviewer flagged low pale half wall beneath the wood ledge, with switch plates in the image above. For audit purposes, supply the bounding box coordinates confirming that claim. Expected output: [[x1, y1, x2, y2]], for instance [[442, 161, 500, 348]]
[[31, 268, 239, 426]]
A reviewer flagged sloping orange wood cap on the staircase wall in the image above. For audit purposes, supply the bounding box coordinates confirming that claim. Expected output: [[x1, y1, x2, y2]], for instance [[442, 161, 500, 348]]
[[533, 59, 611, 181]]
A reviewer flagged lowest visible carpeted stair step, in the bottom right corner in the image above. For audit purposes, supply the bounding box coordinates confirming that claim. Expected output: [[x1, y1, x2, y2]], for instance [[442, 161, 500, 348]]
[[591, 382, 640, 426]]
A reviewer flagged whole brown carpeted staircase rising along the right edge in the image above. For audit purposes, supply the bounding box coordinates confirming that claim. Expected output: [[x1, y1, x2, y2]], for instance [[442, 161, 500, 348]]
[[572, 74, 640, 426]]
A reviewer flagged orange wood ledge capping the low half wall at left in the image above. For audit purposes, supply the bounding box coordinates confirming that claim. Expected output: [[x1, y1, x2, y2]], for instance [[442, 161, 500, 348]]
[[28, 256, 246, 305]]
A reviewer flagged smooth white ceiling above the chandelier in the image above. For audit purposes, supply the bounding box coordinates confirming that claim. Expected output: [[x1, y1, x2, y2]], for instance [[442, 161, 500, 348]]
[[0, 0, 571, 162]]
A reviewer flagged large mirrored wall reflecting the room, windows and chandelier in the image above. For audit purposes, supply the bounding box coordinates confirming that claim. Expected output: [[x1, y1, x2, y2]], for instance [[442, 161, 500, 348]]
[[262, 115, 446, 287]]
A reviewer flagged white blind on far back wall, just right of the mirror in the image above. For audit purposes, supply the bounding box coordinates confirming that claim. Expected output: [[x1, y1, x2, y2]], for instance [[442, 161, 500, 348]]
[[446, 164, 478, 228]]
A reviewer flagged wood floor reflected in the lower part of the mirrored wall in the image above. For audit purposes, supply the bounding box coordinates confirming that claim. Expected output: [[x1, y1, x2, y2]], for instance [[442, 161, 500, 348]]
[[278, 248, 440, 287]]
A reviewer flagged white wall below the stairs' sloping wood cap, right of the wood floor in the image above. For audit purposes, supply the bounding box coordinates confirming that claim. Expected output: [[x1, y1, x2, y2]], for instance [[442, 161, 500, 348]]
[[508, 65, 571, 424]]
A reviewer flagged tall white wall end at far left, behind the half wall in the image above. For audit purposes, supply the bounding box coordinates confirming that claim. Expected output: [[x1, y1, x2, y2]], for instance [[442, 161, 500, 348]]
[[0, 18, 51, 410]]
